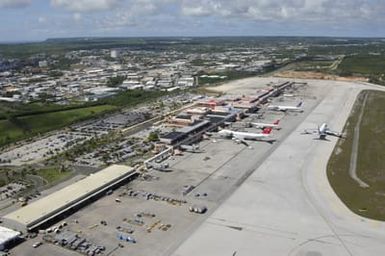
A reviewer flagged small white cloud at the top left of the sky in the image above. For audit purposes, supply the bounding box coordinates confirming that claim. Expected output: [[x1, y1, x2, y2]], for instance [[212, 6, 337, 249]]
[[51, 0, 123, 12]]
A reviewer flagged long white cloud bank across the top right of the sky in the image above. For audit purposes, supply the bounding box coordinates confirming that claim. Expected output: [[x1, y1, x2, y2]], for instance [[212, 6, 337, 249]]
[[181, 0, 385, 22]]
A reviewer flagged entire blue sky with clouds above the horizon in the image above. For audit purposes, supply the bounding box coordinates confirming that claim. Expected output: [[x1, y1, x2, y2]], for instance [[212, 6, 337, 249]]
[[0, 0, 385, 42]]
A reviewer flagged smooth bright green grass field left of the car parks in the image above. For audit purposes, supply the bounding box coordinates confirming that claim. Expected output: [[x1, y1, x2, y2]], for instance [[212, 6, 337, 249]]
[[0, 105, 117, 145]]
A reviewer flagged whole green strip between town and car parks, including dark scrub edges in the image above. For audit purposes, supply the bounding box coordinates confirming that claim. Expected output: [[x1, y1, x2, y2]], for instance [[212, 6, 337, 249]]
[[0, 90, 164, 146]]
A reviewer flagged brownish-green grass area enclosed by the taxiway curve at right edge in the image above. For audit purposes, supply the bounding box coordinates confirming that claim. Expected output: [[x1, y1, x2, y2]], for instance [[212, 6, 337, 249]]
[[328, 91, 385, 221]]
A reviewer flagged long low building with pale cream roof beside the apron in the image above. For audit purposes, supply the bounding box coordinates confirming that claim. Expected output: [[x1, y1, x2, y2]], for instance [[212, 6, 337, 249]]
[[2, 165, 136, 232]]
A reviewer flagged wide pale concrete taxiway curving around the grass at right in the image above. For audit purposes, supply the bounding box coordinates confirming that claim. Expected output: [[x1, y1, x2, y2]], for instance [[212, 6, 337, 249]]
[[173, 80, 385, 256]]
